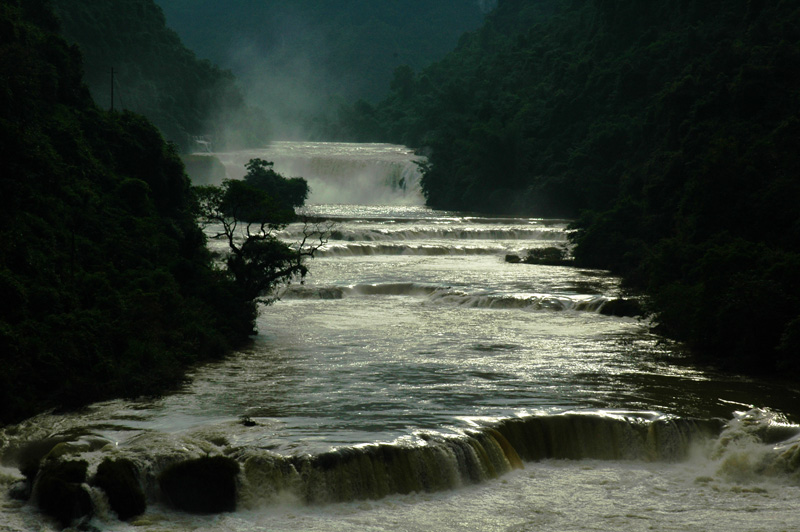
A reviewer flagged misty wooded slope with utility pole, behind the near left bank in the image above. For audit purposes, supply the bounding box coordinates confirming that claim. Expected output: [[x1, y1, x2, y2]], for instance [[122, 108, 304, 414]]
[[52, 0, 269, 151]]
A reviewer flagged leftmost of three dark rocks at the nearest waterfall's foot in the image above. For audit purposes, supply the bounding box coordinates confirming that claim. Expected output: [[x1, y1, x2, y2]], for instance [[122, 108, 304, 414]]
[[36, 460, 92, 528]]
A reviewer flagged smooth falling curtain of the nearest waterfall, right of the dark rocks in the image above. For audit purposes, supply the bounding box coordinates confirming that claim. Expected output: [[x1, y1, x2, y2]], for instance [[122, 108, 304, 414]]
[[234, 413, 721, 504]]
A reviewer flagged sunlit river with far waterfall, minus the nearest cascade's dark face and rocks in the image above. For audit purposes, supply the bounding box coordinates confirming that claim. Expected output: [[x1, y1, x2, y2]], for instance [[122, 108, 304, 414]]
[[0, 143, 800, 531]]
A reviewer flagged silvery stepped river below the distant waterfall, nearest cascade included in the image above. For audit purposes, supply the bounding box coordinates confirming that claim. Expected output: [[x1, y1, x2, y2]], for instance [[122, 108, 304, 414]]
[[0, 201, 800, 532]]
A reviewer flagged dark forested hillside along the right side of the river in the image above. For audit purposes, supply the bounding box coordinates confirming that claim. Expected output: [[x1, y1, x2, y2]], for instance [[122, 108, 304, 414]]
[[340, 0, 800, 372]]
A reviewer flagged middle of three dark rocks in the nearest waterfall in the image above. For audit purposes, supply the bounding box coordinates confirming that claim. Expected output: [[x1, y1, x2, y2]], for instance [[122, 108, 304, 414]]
[[92, 458, 147, 521]]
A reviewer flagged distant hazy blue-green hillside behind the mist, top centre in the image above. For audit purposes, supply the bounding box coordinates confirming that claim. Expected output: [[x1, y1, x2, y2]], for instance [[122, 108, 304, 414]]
[[150, 0, 493, 137]]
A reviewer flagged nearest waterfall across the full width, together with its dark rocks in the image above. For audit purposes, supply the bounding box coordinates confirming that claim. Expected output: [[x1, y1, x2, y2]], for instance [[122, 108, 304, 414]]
[[6, 409, 800, 522]]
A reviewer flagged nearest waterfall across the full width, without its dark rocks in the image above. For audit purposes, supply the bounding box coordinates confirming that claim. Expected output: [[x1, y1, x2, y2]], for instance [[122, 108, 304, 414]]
[[2, 409, 800, 508]]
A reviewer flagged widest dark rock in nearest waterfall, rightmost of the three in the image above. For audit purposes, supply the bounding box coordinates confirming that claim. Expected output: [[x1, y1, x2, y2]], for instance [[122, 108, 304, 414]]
[[159, 456, 239, 514]]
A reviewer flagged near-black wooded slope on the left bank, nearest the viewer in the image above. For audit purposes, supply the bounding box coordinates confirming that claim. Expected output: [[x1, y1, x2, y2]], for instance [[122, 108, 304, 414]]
[[0, 0, 255, 423]]
